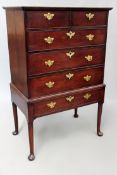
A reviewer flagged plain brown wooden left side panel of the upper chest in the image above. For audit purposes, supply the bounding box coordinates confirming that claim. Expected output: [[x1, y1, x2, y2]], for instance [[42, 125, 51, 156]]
[[6, 9, 28, 97]]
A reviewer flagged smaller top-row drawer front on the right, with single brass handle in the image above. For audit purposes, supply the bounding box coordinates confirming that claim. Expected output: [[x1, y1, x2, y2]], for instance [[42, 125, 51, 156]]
[[72, 11, 108, 26]]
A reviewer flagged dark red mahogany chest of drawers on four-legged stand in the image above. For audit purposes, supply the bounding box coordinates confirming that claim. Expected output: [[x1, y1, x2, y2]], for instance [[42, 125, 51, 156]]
[[6, 7, 110, 160]]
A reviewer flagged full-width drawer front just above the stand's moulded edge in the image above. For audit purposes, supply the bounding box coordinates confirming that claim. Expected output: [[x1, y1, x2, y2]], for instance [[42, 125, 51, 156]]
[[29, 67, 104, 98]]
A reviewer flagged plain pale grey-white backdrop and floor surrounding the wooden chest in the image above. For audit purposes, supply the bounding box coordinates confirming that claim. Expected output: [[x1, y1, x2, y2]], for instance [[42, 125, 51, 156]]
[[0, 0, 117, 175]]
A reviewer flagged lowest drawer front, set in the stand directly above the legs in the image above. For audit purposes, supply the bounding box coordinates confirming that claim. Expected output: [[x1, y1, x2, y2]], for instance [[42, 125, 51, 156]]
[[34, 87, 104, 116]]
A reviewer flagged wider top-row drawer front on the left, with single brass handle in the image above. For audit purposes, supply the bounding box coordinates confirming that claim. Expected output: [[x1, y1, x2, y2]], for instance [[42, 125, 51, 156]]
[[26, 11, 69, 28]]
